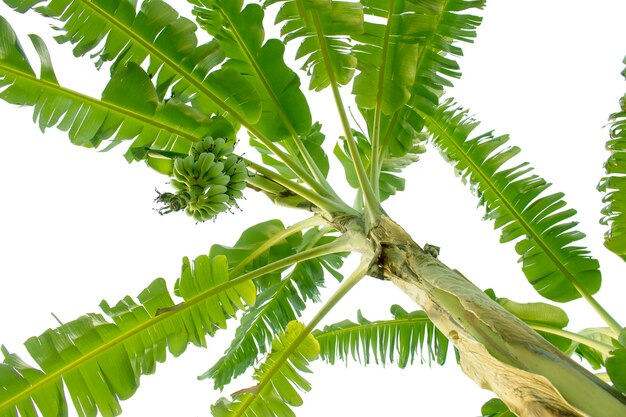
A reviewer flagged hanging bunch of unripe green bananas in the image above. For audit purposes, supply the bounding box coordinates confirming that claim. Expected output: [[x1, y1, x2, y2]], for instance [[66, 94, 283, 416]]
[[156, 137, 248, 222]]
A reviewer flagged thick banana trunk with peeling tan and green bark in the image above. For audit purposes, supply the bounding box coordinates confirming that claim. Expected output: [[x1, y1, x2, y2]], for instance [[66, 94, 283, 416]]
[[370, 217, 626, 417]]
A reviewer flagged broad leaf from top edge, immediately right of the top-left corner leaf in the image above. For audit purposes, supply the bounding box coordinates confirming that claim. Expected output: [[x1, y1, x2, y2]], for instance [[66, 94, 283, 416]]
[[190, 0, 311, 141]]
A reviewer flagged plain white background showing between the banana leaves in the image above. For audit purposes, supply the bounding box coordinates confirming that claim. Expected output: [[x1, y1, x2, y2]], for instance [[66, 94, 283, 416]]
[[0, 0, 626, 417]]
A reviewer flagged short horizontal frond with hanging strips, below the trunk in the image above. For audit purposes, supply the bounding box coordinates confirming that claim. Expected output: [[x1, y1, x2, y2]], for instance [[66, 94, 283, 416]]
[[313, 305, 448, 368]]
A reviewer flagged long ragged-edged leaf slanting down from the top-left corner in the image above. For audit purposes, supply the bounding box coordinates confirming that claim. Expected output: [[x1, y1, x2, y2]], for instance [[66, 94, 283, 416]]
[[5, 0, 261, 125]]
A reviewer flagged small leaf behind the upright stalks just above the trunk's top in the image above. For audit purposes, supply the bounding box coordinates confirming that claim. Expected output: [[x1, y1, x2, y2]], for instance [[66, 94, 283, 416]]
[[334, 130, 426, 201]]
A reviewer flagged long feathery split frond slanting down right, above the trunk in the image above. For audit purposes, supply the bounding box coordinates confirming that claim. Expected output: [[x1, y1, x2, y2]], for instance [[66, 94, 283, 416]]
[[426, 101, 601, 302]]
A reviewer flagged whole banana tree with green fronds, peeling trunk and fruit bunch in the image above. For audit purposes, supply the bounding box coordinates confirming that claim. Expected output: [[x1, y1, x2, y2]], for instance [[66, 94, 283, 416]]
[[0, 0, 626, 417]]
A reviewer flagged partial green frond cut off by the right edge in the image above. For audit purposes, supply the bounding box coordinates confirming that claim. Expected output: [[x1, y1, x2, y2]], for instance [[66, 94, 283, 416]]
[[598, 58, 626, 260]]
